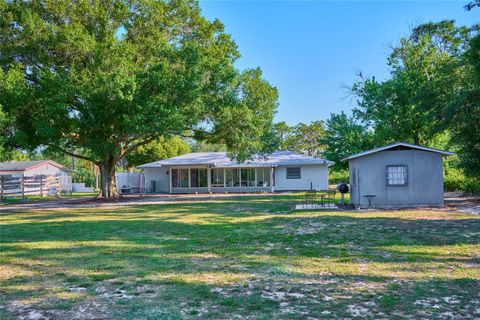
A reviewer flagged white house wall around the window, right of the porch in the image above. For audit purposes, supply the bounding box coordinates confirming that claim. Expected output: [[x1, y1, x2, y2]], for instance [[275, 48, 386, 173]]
[[275, 165, 328, 191]]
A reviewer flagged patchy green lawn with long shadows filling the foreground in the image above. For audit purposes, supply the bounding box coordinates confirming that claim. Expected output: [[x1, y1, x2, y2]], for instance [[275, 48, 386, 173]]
[[0, 195, 480, 320]]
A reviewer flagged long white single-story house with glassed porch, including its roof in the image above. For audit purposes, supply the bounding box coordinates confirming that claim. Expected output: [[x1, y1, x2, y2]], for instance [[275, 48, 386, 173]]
[[138, 151, 333, 193]]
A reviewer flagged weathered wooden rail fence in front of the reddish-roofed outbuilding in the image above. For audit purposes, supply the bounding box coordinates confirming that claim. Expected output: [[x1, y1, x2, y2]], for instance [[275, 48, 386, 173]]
[[0, 175, 71, 201]]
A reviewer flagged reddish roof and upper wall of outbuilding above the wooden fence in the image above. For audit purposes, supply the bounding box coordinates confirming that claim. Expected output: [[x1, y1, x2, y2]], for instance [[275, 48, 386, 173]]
[[0, 160, 72, 177]]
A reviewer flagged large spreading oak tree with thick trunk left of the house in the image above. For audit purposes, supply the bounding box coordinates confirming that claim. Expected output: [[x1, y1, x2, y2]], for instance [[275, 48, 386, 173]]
[[0, 0, 277, 197]]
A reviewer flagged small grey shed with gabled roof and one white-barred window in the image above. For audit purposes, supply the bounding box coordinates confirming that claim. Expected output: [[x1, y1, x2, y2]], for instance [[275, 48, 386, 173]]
[[343, 142, 453, 208]]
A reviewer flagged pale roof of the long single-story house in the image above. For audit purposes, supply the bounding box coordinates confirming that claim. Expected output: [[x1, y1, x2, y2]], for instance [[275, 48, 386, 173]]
[[137, 151, 334, 169]]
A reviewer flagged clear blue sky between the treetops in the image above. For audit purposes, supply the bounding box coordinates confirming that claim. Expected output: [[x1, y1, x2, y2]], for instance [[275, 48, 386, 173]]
[[200, 0, 480, 125]]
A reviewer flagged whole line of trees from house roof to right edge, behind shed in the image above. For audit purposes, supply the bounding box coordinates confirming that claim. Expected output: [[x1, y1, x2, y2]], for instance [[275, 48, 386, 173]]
[[275, 21, 480, 178]]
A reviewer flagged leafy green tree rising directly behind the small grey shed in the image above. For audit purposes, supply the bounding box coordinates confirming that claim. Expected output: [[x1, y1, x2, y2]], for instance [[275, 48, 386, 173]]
[[352, 21, 469, 146]]
